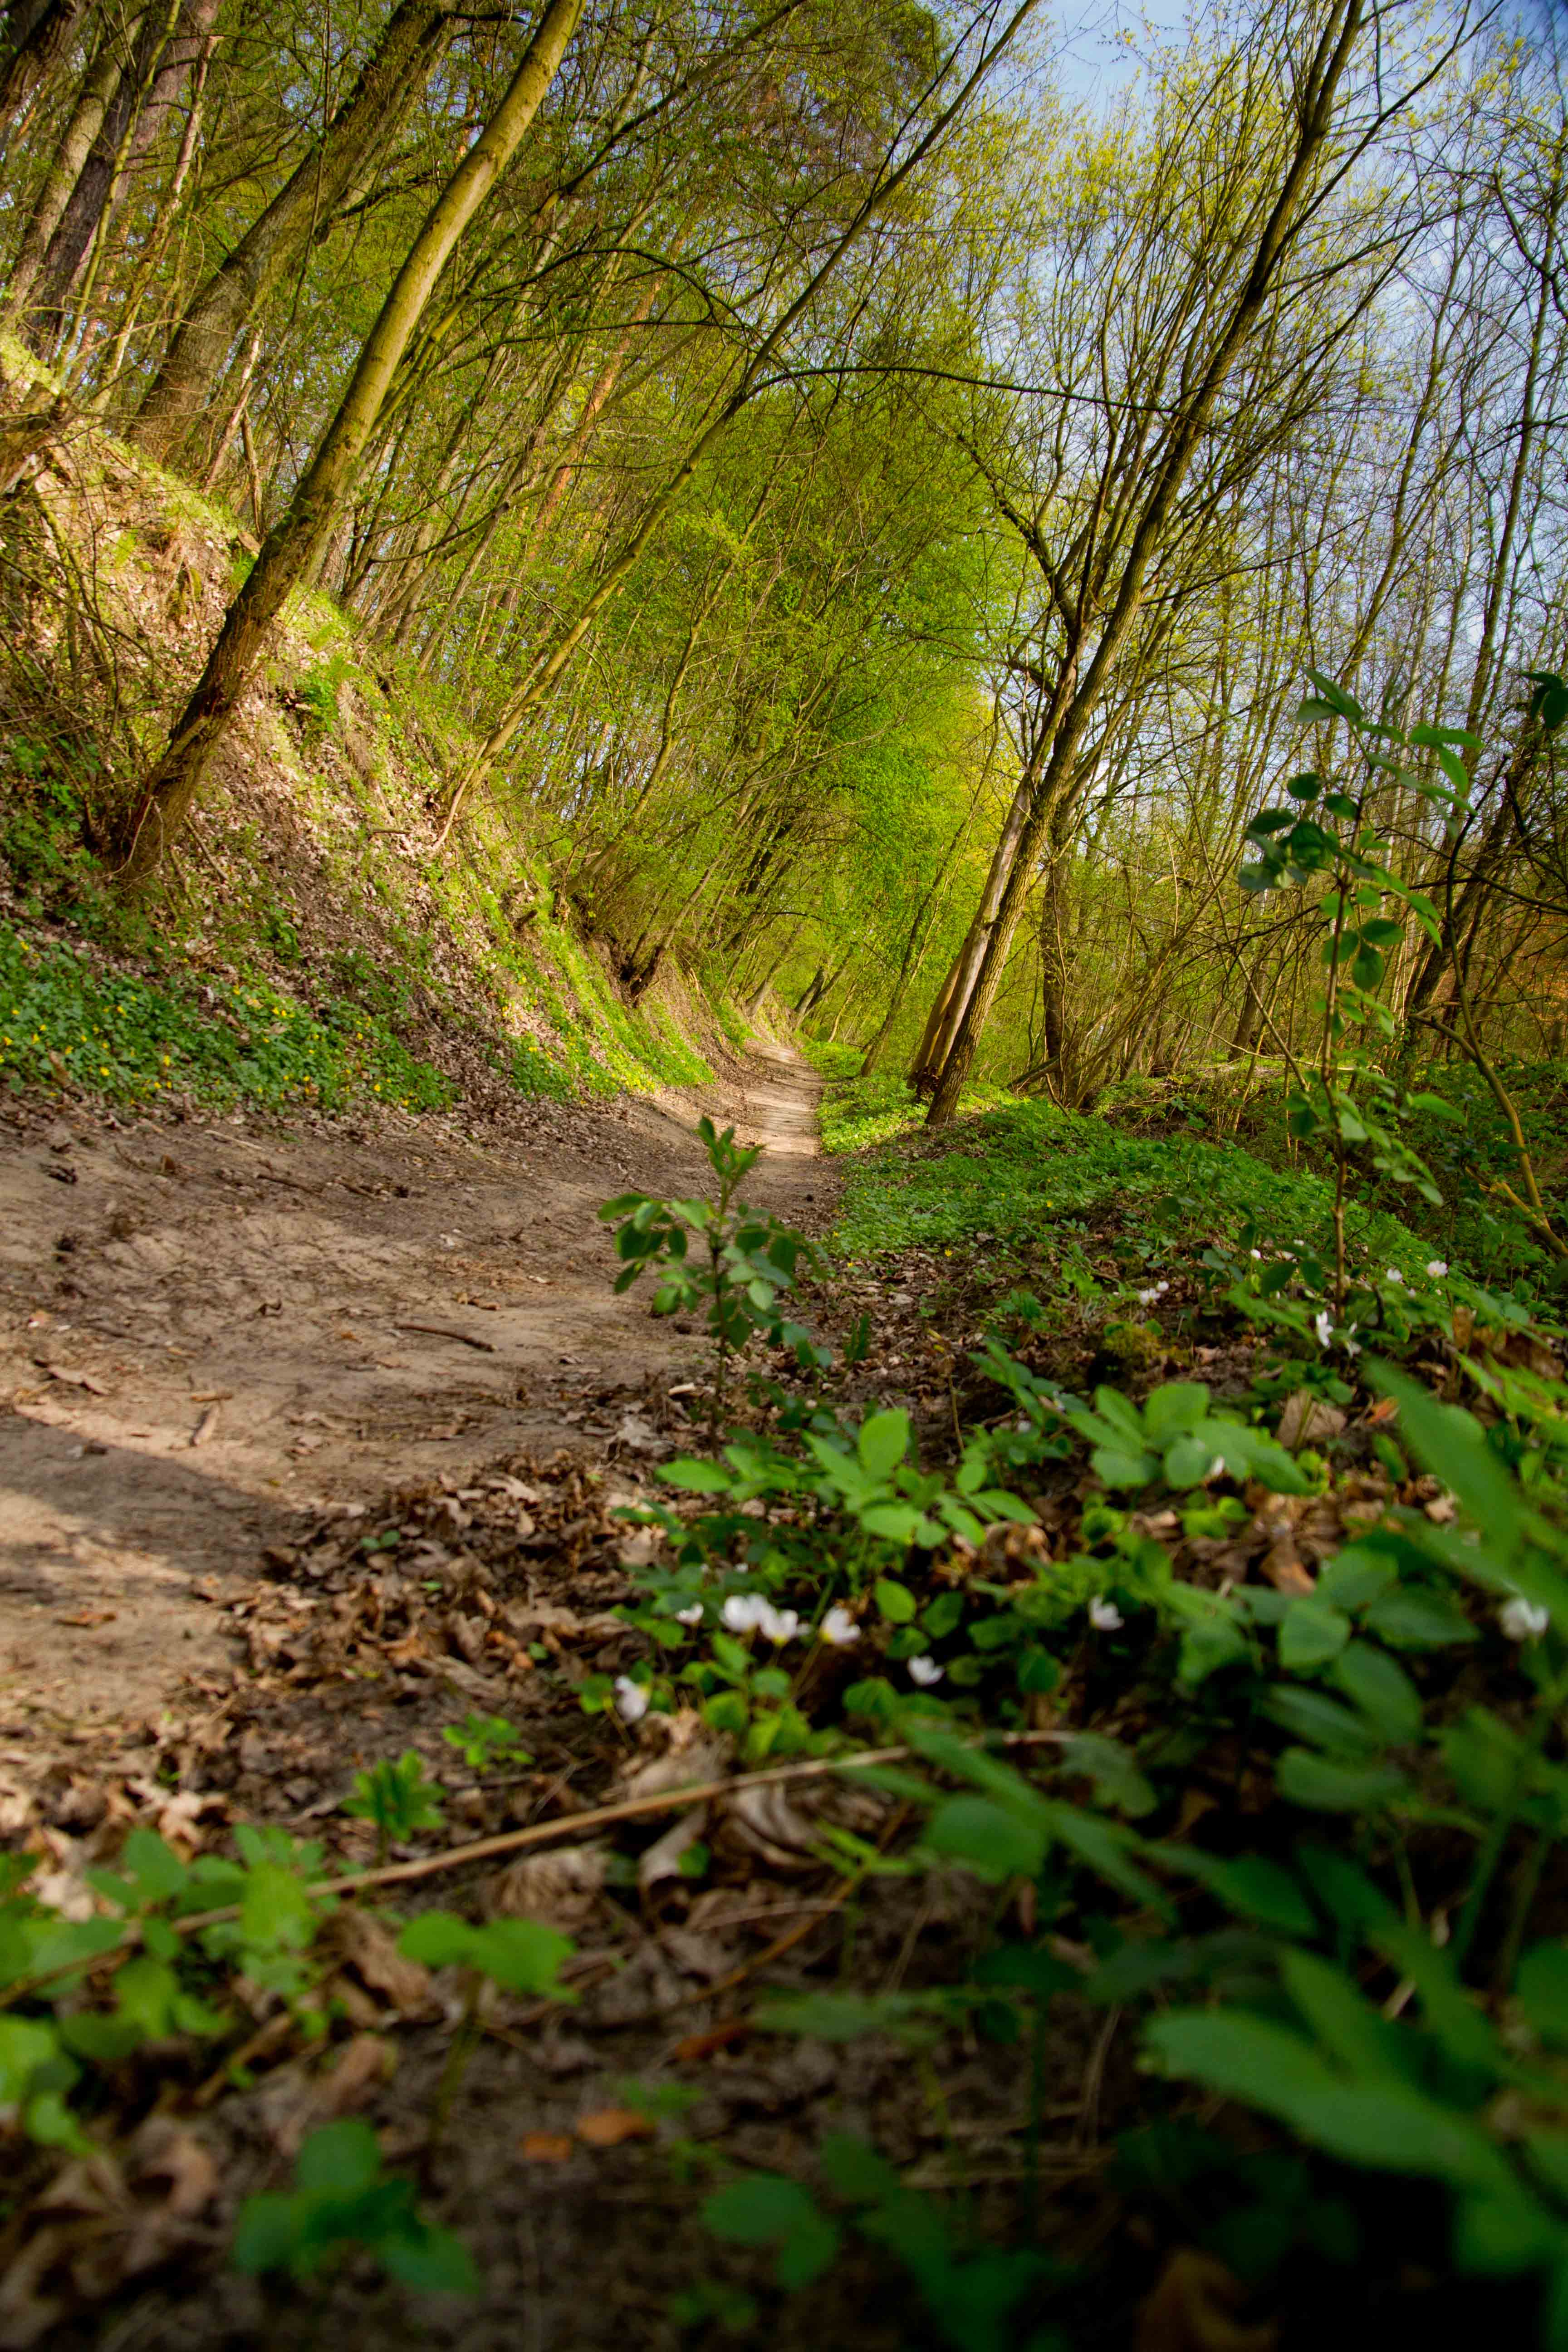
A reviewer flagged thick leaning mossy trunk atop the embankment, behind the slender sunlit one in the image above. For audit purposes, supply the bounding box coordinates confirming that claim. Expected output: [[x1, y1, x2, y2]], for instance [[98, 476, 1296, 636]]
[[132, 0, 451, 463]]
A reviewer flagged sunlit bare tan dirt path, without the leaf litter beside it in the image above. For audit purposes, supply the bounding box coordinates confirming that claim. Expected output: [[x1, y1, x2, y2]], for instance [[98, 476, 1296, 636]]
[[0, 1047, 834, 1738]]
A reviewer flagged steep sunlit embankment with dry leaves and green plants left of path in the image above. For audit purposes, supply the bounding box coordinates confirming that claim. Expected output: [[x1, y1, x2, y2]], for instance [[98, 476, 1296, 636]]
[[0, 341, 740, 1117]]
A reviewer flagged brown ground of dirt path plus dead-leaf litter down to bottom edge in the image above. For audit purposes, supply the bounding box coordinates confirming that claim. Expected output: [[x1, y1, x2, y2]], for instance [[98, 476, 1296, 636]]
[[0, 1051, 1100, 2352]]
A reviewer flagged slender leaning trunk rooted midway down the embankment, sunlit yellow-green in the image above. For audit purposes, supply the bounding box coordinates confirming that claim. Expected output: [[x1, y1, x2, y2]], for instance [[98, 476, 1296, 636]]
[[120, 0, 583, 889]]
